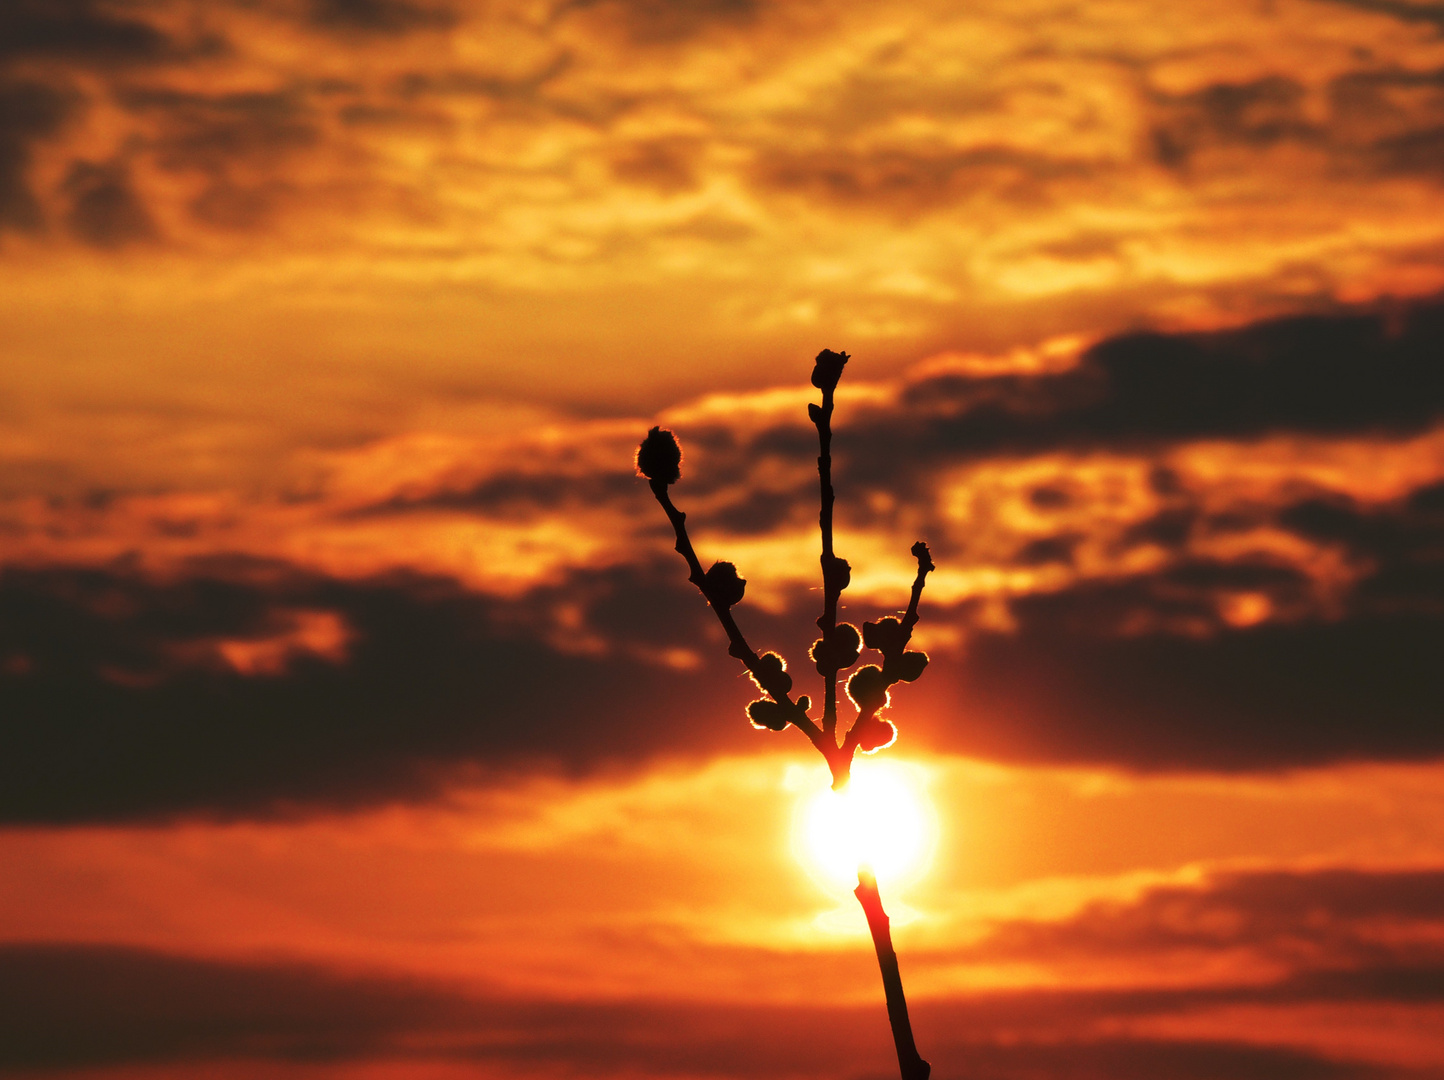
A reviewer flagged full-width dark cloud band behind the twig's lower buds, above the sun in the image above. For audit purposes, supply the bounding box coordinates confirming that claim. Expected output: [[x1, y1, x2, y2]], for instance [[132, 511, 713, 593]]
[[0, 528, 1444, 822]]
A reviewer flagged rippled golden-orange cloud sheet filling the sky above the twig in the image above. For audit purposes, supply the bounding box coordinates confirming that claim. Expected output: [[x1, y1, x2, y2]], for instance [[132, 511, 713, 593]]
[[0, 0, 1444, 472]]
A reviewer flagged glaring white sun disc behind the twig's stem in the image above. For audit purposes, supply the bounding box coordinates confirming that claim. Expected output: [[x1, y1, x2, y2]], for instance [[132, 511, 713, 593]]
[[794, 761, 937, 891]]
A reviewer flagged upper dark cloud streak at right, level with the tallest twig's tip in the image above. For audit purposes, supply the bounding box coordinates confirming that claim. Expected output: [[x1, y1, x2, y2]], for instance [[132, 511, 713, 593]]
[[889, 298, 1444, 453]]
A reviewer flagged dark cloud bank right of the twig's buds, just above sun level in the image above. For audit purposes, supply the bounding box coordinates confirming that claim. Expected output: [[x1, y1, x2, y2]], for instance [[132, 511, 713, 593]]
[[915, 588, 1444, 770]]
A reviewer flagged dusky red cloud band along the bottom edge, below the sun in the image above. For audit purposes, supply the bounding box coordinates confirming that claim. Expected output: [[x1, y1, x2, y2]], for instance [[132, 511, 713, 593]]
[[0, 871, 1444, 1080]]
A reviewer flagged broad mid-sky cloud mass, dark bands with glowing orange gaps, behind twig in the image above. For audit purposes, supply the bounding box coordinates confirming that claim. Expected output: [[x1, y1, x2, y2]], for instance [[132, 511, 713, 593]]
[[8, 298, 1444, 820]]
